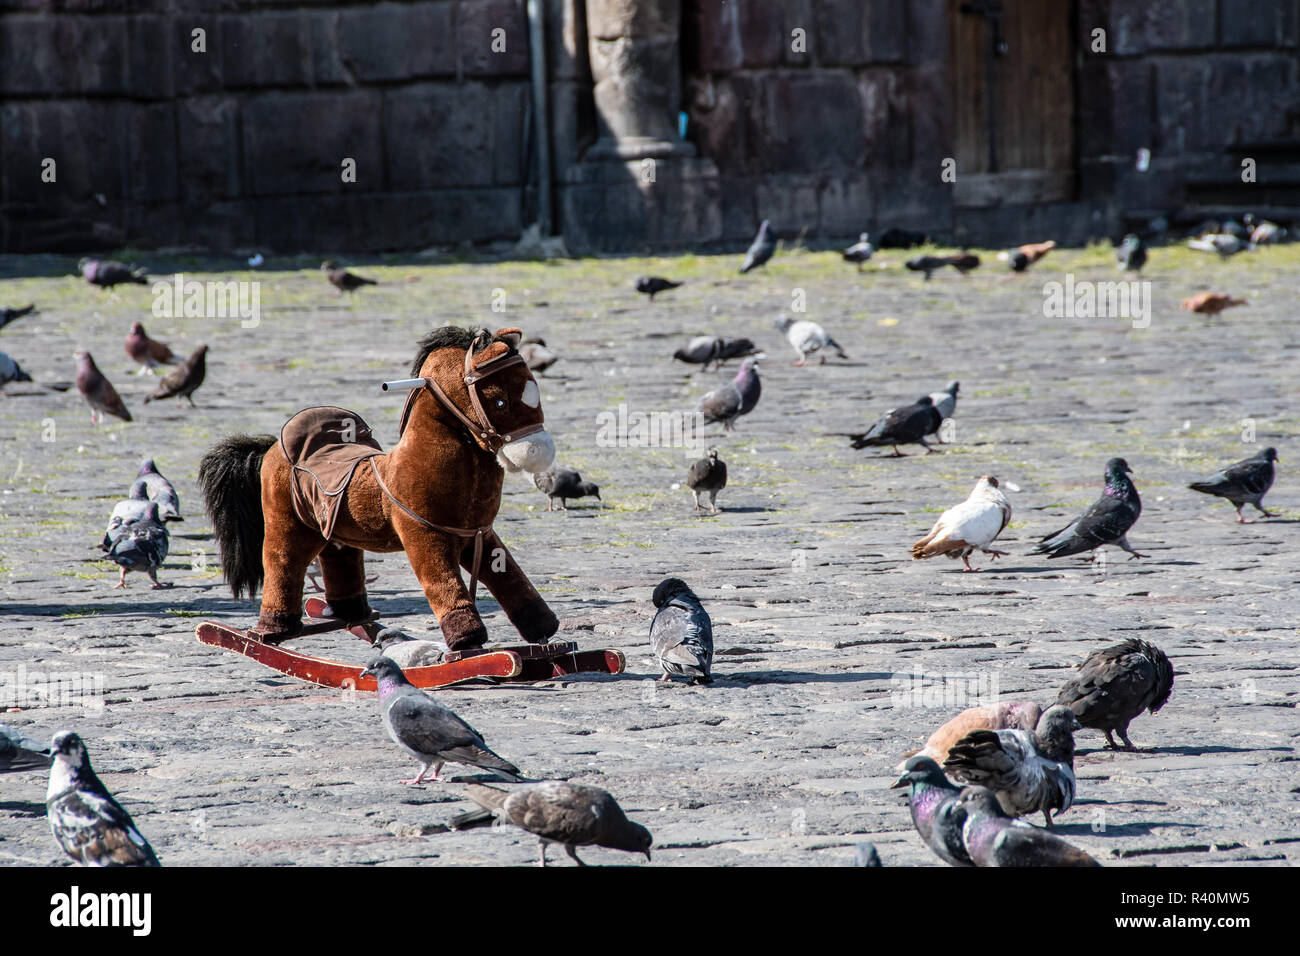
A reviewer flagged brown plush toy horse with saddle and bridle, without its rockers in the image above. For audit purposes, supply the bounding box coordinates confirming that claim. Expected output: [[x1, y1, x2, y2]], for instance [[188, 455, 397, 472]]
[[199, 326, 559, 650]]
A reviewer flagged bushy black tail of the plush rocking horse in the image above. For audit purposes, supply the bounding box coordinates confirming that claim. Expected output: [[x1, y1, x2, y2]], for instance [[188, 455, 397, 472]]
[[199, 434, 276, 597]]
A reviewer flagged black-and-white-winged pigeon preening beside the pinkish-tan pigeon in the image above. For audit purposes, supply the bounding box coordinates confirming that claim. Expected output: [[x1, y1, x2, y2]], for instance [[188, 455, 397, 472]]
[[941, 705, 1080, 826]]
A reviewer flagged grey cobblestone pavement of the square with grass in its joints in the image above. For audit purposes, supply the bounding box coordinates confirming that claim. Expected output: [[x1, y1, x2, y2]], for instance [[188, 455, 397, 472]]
[[0, 247, 1300, 866]]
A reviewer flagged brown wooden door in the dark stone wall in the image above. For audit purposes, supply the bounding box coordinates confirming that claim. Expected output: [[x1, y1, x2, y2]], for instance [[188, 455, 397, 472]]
[[949, 0, 1079, 207]]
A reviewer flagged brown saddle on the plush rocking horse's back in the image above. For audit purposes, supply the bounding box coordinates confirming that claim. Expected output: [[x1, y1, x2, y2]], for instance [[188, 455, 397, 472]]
[[280, 405, 384, 540]]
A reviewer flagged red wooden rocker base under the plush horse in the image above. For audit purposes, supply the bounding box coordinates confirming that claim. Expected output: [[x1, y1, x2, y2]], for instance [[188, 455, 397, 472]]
[[195, 597, 627, 691]]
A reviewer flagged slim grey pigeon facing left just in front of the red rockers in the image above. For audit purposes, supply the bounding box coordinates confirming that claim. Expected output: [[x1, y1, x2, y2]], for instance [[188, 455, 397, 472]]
[[360, 656, 523, 783]]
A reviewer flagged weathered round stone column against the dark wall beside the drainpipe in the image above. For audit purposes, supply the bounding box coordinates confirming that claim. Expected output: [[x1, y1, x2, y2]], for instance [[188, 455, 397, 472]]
[[585, 0, 696, 161]]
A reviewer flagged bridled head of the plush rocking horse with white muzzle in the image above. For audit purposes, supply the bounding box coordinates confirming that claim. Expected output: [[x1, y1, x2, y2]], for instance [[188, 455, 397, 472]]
[[402, 325, 555, 473]]
